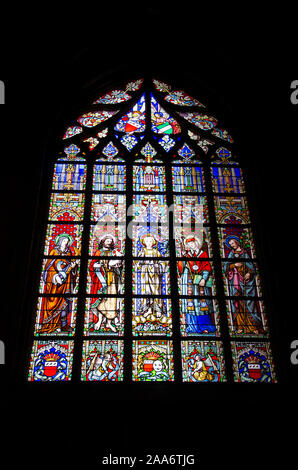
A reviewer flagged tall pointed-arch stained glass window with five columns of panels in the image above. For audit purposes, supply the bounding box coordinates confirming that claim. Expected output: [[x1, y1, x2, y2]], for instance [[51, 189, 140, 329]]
[[28, 78, 276, 383]]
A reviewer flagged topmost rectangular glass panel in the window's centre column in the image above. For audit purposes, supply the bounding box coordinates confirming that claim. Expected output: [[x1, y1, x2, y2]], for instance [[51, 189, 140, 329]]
[[133, 165, 166, 192]]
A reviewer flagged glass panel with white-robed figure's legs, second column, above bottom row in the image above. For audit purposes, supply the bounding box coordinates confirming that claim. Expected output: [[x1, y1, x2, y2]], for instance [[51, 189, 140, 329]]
[[84, 297, 124, 336]]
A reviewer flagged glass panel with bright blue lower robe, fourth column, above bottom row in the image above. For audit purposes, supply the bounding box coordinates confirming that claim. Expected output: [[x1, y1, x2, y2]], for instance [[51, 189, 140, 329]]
[[179, 297, 220, 337]]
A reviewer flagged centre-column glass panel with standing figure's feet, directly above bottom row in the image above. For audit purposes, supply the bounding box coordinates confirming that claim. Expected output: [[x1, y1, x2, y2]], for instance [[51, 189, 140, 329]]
[[132, 297, 172, 336]]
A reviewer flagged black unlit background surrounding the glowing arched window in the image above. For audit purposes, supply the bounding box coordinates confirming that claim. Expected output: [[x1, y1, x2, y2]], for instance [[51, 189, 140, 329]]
[[0, 3, 298, 468]]
